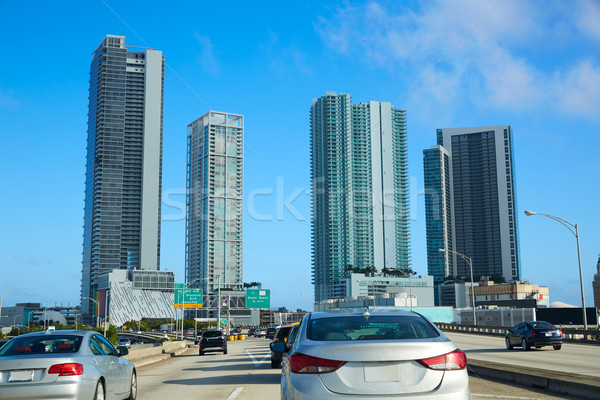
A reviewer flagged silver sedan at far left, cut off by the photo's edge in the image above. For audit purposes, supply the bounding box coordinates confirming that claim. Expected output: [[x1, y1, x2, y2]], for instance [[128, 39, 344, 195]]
[[0, 331, 137, 400]]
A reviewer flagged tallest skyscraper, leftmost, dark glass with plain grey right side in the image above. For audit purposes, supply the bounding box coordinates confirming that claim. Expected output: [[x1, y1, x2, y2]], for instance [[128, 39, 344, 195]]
[[81, 35, 164, 322]]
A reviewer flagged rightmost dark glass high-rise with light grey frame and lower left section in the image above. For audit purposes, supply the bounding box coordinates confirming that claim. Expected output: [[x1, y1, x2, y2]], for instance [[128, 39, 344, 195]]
[[423, 126, 521, 304]]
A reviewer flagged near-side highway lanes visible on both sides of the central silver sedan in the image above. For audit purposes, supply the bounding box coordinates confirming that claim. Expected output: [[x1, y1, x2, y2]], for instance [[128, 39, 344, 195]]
[[138, 338, 580, 400]]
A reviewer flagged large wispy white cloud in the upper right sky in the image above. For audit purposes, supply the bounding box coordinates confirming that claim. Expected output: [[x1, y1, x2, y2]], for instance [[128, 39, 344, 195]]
[[315, 0, 600, 118]]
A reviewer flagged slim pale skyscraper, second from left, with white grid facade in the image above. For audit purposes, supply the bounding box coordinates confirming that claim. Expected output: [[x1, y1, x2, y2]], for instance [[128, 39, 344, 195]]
[[185, 111, 244, 294]]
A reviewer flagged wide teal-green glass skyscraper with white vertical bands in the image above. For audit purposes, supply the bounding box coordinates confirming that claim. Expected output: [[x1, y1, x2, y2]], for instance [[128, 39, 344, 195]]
[[310, 92, 410, 301]]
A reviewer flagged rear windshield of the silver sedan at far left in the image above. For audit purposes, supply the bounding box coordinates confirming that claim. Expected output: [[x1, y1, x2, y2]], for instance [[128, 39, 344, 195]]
[[0, 335, 83, 356]]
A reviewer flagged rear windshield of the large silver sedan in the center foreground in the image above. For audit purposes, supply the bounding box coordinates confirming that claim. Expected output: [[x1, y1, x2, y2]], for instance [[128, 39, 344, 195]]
[[306, 315, 439, 341]]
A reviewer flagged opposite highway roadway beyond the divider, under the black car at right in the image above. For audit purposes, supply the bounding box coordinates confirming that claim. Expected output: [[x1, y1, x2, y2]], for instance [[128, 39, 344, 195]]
[[444, 332, 600, 377]]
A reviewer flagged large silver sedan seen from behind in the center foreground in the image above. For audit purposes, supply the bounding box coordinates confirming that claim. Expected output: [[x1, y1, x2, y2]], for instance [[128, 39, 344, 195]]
[[274, 311, 471, 400]]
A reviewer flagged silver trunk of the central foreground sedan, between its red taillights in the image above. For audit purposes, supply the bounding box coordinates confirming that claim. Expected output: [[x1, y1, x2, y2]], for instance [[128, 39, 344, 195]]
[[309, 339, 455, 396]]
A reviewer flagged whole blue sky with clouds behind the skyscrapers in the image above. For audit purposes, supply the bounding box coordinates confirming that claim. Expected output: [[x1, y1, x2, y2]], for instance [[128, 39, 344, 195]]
[[0, 0, 600, 309]]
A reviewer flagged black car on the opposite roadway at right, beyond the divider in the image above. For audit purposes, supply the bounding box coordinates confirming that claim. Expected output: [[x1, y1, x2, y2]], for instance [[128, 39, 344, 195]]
[[505, 321, 563, 351]]
